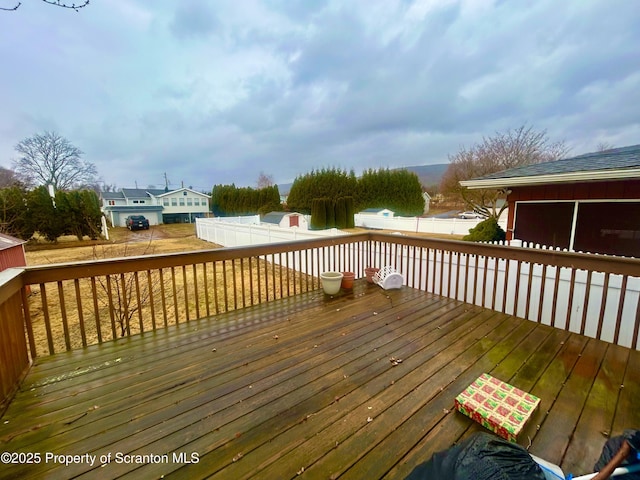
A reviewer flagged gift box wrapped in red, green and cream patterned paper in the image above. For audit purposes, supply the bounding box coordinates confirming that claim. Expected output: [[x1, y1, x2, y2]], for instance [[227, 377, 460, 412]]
[[456, 373, 540, 442]]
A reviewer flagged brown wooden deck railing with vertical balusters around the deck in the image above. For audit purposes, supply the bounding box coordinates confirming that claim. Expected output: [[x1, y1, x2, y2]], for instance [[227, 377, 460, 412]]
[[0, 232, 640, 407]]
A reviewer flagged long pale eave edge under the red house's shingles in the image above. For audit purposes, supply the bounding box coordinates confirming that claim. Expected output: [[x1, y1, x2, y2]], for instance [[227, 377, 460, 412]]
[[460, 168, 640, 189]]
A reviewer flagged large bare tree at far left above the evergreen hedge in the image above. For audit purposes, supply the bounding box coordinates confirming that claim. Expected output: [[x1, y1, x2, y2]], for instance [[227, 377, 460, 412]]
[[13, 132, 97, 190]]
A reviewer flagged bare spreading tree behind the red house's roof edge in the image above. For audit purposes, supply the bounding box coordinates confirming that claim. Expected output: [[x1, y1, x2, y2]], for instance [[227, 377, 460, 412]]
[[440, 125, 569, 217]]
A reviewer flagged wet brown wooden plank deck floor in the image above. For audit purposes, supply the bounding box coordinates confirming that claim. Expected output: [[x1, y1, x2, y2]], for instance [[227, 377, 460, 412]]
[[0, 282, 640, 479]]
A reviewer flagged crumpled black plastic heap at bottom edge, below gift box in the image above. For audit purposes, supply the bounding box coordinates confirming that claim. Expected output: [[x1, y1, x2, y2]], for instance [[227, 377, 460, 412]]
[[407, 432, 545, 480]]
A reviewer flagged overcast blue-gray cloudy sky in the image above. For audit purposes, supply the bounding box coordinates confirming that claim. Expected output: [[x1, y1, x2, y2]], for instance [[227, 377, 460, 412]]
[[0, 0, 640, 190]]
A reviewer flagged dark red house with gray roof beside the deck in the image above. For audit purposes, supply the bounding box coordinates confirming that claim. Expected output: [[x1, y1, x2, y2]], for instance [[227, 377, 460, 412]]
[[460, 145, 640, 257]]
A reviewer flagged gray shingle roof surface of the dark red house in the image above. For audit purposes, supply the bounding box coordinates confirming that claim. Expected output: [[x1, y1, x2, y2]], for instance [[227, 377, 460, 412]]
[[473, 145, 640, 180]]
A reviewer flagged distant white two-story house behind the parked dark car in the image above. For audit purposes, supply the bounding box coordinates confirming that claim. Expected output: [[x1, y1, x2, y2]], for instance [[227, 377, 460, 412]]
[[100, 188, 211, 227]]
